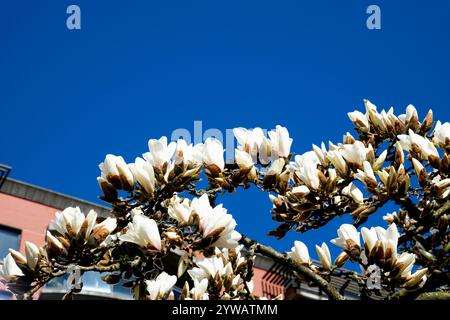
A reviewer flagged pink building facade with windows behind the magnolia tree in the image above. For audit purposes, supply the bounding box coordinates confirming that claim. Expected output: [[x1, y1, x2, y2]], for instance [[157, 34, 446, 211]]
[[0, 178, 357, 300]]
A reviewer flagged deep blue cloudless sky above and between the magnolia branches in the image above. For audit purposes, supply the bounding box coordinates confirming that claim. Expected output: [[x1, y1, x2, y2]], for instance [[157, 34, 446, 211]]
[[0, 0, 450, 255]]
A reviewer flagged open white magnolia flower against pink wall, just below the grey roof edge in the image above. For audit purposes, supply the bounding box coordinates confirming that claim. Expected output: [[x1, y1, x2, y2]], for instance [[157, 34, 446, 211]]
[[48, 207, 85, 237]]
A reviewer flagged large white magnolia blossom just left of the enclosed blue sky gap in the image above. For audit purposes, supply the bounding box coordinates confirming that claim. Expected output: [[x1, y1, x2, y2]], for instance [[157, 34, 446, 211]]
[[191, 194, 241, 248]]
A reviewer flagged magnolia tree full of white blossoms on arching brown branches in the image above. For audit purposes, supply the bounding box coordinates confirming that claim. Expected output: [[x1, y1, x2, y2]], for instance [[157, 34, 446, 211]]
[[0, 100, 450, 300]]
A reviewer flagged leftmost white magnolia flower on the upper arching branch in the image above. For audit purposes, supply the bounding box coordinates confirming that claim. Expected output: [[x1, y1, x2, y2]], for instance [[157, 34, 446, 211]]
[[99, 154, 134, 191]]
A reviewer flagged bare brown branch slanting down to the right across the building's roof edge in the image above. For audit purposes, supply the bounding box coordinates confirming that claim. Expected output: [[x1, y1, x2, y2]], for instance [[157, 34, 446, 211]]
[[240, 236, 345, 300]]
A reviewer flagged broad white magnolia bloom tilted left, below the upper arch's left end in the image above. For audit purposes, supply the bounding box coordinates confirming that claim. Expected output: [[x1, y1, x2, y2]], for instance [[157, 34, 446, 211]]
[[119, 215, 161, 251]]
